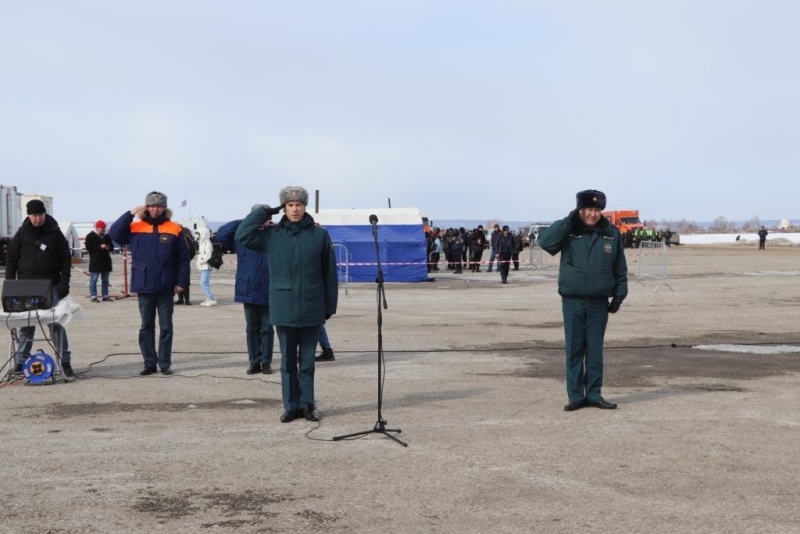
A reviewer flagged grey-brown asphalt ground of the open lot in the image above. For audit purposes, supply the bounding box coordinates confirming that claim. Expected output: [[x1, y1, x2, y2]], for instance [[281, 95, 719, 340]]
[[0, 246, 800, 533]]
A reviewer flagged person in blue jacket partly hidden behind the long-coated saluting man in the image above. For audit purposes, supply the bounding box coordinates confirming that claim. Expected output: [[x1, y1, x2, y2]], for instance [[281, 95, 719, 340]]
[[217, 204, 275, 375]]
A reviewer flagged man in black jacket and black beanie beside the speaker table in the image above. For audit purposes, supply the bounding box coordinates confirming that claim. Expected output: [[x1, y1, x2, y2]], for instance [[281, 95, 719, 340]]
[[5, 199, 75, 377]]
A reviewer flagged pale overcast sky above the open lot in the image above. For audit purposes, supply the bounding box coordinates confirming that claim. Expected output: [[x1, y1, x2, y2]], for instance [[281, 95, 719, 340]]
[[0, 0, 800, 226]]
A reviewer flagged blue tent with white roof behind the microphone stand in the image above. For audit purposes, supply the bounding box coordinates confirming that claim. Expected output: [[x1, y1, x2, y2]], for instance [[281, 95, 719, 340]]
[[310, 208, 428, 282]]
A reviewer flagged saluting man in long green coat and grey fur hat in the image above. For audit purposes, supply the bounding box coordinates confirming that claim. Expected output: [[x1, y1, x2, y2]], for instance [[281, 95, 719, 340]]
[[235, 186, 339, 423]]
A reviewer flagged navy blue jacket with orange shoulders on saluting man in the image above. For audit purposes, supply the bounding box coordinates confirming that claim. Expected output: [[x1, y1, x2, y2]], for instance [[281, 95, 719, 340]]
[[108, 211, 189, 294]]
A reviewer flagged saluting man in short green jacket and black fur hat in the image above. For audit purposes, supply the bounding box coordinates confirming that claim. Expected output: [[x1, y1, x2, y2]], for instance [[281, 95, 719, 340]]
[[539, 189, 628, 412]]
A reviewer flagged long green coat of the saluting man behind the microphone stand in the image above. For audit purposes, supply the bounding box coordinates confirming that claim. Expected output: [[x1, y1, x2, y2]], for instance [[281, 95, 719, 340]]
[[235, 209, 339, 328]]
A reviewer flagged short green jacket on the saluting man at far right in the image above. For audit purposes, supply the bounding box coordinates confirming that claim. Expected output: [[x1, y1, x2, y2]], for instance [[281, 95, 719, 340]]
[[539, 217, 628, 302]]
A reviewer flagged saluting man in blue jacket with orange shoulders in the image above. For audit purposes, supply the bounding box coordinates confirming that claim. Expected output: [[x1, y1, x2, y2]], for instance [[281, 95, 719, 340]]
[[108, 191, 189, 376]]
